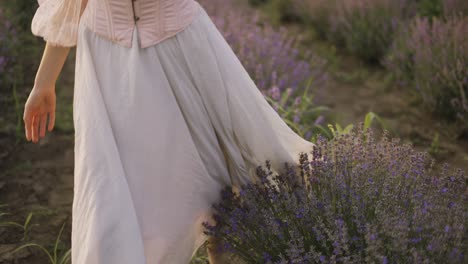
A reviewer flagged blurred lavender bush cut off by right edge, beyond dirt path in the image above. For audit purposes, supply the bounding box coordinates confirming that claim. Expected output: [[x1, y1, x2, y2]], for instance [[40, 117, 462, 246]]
[[385, 16, 468, 122]]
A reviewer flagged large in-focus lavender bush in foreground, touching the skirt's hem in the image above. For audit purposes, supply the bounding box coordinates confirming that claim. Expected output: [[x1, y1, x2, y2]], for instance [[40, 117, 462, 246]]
[[203, 127, 468, 263]]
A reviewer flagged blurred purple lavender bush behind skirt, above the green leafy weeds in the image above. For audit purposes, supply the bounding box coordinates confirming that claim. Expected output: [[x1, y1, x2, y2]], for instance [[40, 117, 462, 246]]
[[200, 0, 326, 94]]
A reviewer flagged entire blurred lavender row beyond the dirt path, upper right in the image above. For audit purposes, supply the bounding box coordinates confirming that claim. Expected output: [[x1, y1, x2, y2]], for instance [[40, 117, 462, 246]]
[[281, 0, 468, 126]]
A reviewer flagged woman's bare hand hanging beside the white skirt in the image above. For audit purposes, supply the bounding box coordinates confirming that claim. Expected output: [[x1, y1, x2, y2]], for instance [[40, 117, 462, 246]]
[[23, 86, 56, 143]]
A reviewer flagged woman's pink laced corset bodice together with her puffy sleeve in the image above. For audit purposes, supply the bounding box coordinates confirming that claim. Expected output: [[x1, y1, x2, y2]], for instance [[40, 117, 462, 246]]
[[31, 0, 199, 48]]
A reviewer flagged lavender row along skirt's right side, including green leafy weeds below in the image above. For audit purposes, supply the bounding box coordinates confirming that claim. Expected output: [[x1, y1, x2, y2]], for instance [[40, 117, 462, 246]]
[[199, 0, 327, 140]]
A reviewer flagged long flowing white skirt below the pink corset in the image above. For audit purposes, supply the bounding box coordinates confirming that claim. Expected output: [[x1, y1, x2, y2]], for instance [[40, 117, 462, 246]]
[[71, 1, 314, 264]]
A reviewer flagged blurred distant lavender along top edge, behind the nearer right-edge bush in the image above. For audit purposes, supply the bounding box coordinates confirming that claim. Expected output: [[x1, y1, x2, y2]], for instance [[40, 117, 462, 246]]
[[290, 0, 468, 62]]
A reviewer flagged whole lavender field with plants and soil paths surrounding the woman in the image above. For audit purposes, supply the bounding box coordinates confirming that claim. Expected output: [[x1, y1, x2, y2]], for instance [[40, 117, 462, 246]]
[[0, 0, 468, 264]]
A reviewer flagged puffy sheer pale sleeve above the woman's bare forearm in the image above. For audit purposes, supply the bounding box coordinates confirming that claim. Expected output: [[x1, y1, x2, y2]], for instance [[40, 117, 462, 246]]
[[31, 0, 88, 47]]
